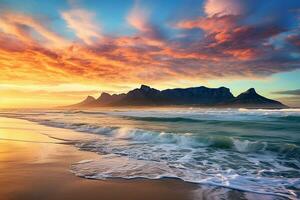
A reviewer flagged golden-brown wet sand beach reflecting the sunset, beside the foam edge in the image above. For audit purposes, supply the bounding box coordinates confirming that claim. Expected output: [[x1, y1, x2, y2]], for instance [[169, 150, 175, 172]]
[[0, 118, 282, 200]]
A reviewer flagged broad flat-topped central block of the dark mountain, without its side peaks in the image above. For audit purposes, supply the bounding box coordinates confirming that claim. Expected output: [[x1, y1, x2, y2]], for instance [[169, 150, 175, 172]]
[[99, 85, 234, 106]]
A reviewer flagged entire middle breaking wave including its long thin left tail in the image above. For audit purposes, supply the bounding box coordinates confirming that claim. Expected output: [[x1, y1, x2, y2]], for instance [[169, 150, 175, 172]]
[[7, 119, 300, 157]]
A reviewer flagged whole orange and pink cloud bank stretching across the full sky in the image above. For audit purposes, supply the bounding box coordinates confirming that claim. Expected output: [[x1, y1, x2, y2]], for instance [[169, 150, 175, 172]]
[[0, 0, 300, 89]]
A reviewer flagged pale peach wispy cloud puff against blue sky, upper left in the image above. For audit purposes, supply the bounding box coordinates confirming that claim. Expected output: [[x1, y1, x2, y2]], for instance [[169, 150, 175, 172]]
[[61, 9, 103, 45]]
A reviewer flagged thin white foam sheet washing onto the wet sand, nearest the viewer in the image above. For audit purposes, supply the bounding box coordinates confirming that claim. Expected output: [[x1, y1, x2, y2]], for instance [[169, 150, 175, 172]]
[[71, 154, 300, 199]]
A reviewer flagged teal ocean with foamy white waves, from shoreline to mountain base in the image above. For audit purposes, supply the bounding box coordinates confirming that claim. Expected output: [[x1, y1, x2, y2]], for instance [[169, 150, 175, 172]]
[[0, 108, 300, 199]]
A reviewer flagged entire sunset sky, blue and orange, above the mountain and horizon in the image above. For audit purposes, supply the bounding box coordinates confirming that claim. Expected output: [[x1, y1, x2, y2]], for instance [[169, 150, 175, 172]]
[[0, 0, 300, 108]]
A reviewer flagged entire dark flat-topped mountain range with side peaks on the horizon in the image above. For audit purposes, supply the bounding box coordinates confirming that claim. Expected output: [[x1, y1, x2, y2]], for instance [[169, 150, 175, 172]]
[[68, 85, 287, 108]]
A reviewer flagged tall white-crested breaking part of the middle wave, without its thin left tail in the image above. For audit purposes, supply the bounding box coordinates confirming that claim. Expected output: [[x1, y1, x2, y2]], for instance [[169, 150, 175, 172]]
[[110, 128, 300, 156]]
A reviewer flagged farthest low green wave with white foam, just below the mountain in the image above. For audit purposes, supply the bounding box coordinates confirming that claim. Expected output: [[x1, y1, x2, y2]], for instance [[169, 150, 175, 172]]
[[114, 109, 300, 123]]
